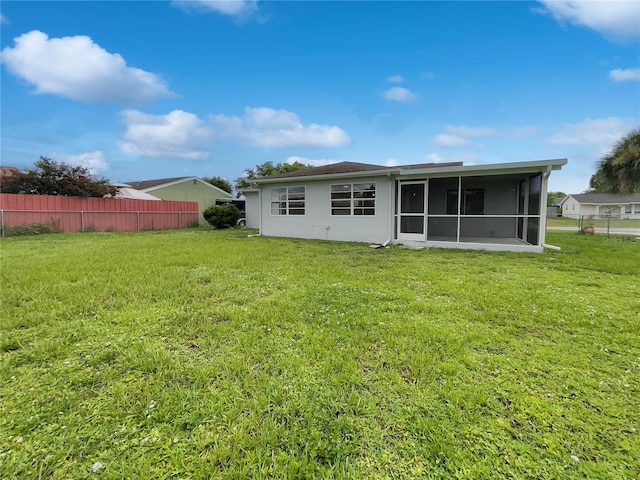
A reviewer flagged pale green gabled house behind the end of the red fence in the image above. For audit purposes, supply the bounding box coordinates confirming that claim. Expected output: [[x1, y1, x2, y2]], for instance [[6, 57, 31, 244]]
[[126, 177, 234, 223]]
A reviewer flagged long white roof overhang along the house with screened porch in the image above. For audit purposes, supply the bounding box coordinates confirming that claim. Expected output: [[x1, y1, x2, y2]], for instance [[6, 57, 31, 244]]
[[251, 158, 567, 185]]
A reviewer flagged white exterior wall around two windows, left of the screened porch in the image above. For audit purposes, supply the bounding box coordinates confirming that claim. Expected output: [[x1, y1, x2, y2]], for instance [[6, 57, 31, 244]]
[[260, 176, 394, 243]]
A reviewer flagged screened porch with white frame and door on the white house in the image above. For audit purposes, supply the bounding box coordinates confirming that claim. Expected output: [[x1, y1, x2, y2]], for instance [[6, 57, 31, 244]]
[[395, 172, 544, 248]]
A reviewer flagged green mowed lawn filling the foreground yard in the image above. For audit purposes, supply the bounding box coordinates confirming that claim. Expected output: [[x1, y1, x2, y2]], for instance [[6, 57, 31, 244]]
[[0, 229, 640, 479]]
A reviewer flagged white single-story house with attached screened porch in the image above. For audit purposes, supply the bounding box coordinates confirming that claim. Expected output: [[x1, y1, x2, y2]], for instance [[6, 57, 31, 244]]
[[245, 159, 567, 252]]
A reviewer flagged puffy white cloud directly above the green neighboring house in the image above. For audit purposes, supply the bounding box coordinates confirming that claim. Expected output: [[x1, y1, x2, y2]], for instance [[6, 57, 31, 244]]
[[118, 110, 212, 160]]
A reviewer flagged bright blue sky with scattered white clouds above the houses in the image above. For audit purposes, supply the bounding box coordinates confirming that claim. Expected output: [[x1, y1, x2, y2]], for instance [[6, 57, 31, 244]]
[[0, 0, 640, 193]]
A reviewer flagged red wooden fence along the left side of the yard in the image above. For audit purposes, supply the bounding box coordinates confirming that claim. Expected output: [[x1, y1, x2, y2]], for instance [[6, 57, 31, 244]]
[[0, 193, 198, 234]]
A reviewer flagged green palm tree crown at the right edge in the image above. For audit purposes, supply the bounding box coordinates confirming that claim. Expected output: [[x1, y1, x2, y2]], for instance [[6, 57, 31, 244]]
[[589, 128, 640, 195]]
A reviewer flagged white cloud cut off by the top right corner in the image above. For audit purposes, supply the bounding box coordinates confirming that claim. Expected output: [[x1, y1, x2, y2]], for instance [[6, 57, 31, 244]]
[[540, 0, 640, 40]]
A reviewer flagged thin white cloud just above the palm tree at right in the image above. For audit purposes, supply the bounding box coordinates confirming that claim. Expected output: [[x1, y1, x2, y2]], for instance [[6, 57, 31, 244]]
[[547, 117, 634, 146]]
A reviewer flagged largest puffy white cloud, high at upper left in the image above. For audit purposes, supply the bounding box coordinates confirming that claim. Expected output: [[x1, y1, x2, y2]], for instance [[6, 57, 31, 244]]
[[0, 30, 173, 104]]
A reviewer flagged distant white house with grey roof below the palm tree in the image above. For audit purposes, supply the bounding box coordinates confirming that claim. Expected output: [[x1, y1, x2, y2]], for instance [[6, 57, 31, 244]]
[[560, 193, 640, 218]]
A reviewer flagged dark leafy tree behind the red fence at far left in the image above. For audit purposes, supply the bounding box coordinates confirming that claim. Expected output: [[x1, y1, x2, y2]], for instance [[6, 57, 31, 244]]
[[0, 157, 118, 197]]
